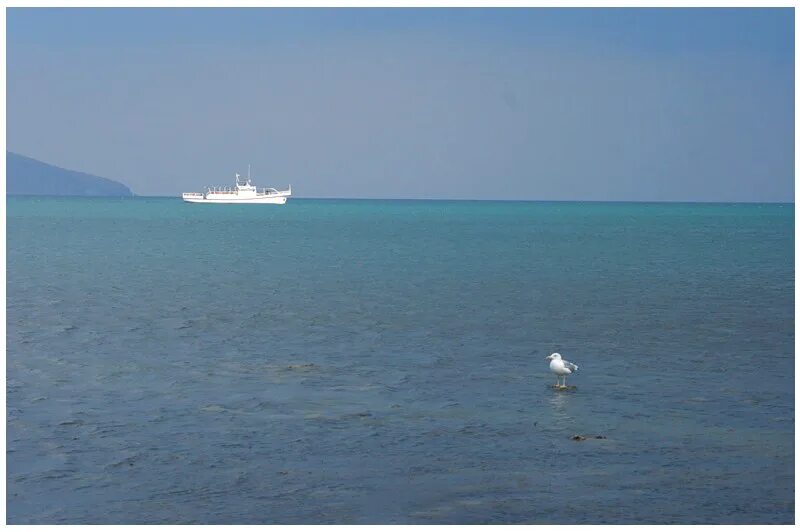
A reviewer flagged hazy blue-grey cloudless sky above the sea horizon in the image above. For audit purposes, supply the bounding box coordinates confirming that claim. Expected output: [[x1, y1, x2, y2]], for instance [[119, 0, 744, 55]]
[[6, 8, 794, 201]]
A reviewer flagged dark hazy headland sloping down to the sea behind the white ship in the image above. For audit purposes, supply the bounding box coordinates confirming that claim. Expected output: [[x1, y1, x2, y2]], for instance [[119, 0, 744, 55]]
[[6, 151, 133, 196]]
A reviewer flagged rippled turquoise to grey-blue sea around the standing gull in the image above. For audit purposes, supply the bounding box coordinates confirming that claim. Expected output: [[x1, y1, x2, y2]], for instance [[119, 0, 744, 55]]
[[7, 198, 794, 523]]
